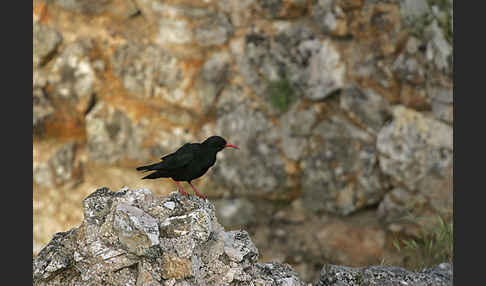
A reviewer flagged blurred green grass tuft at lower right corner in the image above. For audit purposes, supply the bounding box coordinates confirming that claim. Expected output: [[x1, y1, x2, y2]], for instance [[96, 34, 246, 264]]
[[393, 216, 454, 270]]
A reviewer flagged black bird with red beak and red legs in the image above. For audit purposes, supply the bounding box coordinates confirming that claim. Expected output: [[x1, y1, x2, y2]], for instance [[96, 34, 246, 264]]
[[137, 136, 240, 199]]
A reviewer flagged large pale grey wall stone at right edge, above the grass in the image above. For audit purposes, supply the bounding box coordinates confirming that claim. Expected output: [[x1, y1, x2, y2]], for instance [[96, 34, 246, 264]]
[[376, 106, 453, 235]]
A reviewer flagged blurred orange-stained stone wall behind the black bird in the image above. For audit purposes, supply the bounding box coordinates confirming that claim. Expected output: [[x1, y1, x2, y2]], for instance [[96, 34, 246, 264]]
[[33, 0, 453, 280]]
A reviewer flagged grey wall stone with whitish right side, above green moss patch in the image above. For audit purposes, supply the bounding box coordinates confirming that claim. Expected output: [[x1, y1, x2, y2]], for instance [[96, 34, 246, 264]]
[[237, 23, 346, 101]]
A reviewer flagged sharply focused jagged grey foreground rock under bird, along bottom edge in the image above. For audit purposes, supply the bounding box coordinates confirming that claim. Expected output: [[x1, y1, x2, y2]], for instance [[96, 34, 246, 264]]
[[32, 188, 452, 286]]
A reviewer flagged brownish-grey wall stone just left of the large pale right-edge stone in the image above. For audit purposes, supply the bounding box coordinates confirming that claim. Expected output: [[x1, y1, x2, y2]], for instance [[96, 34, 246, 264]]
[[300, 116, 388, 215]]
